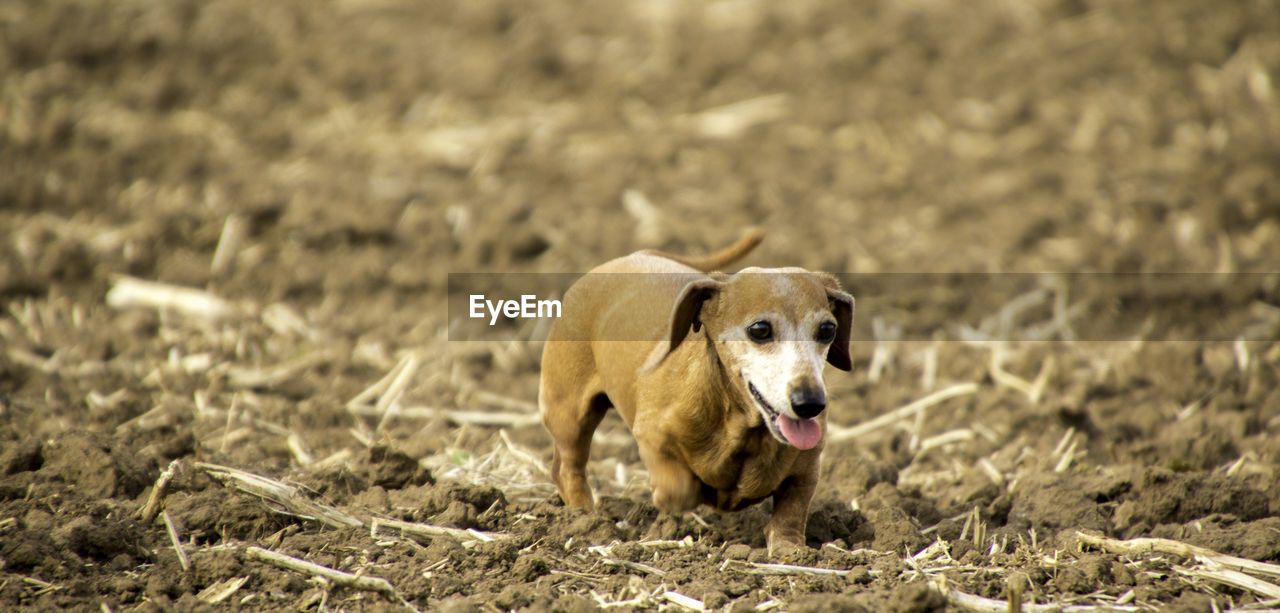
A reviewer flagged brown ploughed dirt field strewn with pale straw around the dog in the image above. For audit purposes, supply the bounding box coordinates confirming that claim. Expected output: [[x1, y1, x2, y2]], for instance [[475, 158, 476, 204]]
[[0, 0, 1280, 612]]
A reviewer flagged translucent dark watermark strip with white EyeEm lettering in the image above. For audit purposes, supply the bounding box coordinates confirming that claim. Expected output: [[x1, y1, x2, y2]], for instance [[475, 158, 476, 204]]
[[445, 271, 1280, 342]]
